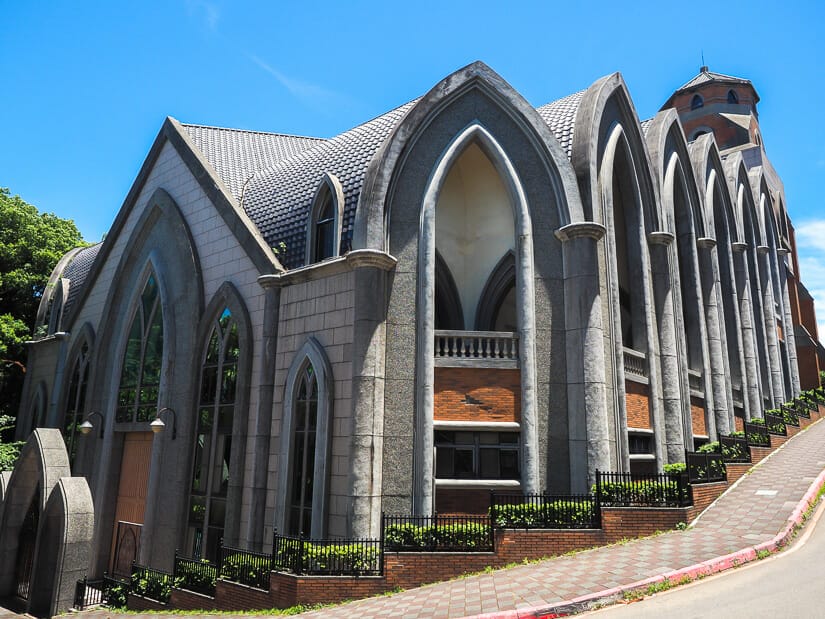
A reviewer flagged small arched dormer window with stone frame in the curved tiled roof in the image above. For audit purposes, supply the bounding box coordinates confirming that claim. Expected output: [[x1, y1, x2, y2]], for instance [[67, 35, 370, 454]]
[[306, 172, 344, 264]]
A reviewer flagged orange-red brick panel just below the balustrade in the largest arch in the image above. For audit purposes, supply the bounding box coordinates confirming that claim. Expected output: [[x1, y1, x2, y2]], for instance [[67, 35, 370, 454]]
[[433, 367, 521, 421]]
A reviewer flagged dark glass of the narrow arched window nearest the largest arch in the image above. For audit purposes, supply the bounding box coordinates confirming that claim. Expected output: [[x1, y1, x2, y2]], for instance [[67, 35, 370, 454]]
[[286, 363, 318, 535]]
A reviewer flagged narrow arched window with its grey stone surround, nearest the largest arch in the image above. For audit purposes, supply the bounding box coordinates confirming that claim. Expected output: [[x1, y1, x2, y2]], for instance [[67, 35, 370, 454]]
[[275, 337, 332, 539]]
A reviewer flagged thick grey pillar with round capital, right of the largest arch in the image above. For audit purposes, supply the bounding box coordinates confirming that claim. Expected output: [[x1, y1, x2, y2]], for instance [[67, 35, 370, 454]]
[[556, 222, 612, 492]]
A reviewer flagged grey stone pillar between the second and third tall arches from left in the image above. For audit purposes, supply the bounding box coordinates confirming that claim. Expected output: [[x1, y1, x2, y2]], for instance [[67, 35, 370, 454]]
[[648, 232, 692, 465]]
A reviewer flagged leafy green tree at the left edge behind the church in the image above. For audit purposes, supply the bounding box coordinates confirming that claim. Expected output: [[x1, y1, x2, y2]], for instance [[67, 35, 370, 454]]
[[0, 187, 86, 432]]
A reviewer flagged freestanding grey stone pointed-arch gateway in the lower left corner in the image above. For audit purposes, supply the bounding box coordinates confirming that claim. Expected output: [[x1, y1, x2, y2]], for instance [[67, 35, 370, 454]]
[[0, 428, 94, 617]]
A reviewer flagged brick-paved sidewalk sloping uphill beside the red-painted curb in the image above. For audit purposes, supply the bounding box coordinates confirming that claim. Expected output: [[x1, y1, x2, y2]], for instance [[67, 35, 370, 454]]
[[11, 422, 825, 619]]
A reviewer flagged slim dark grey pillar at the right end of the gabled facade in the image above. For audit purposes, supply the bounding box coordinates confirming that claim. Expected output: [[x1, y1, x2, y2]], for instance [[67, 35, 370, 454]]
[[246, 275, 287, 551]]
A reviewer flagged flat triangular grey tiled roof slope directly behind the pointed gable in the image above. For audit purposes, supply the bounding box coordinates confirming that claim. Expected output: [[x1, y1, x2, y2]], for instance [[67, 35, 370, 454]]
[[183, 124, 324, 200]]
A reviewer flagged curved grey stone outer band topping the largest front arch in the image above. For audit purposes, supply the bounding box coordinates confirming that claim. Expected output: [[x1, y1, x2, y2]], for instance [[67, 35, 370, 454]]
[[353, 61, 584, 250]]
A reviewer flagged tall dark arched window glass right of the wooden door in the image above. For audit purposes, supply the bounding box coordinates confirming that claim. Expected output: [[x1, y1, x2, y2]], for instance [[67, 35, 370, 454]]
[[187, 308, 240, 560]]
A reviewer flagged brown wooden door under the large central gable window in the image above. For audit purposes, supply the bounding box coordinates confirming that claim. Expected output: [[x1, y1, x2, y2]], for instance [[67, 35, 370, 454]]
[[109, 432, 153, 572]]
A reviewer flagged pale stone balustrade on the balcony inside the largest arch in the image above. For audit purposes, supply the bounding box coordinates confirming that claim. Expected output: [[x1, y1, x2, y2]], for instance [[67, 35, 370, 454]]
[[435, 331, 518, 367]]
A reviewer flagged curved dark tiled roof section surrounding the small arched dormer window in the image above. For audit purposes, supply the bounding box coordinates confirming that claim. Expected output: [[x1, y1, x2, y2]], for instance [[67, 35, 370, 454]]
[[243, 100, 417, 269]]
